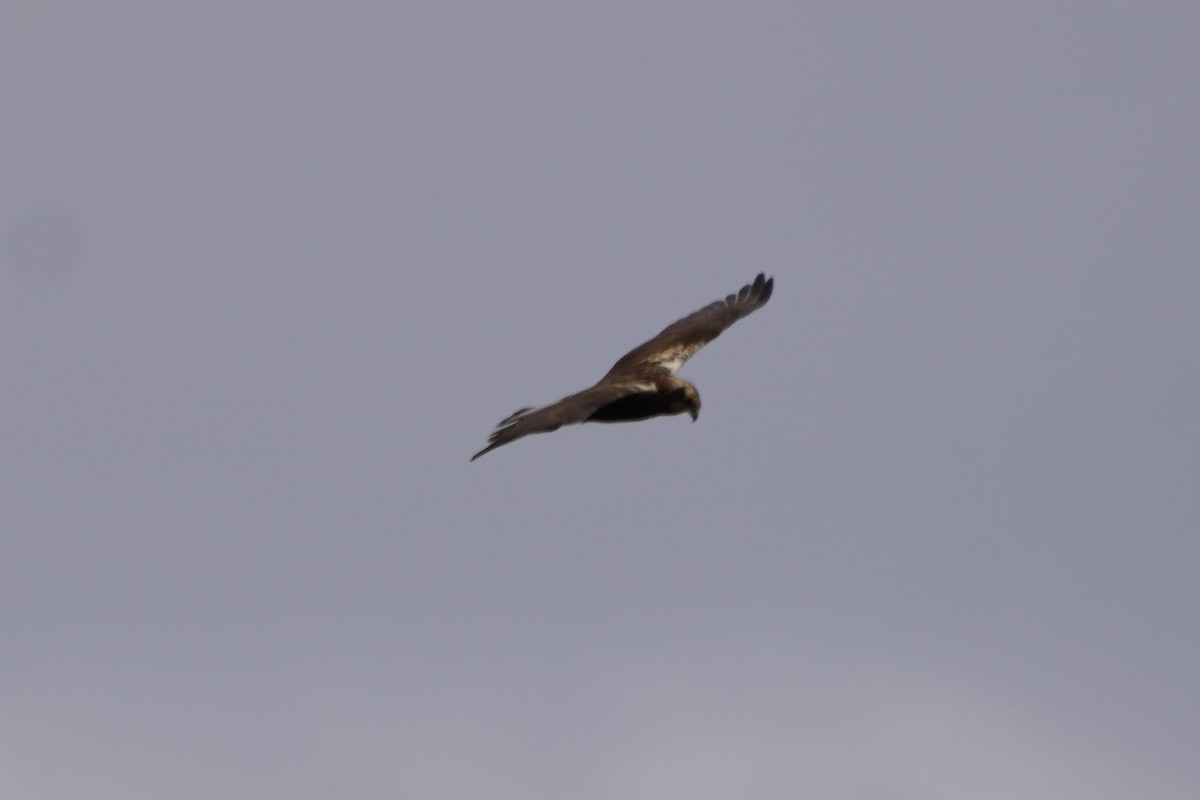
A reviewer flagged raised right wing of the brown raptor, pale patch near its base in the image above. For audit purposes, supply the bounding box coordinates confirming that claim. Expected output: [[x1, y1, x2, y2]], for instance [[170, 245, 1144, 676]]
[[600, 272, 775, 384]]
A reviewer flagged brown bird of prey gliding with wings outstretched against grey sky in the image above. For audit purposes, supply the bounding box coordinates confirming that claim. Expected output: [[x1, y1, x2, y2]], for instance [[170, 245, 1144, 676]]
[[470, 272, 775, 461]]
